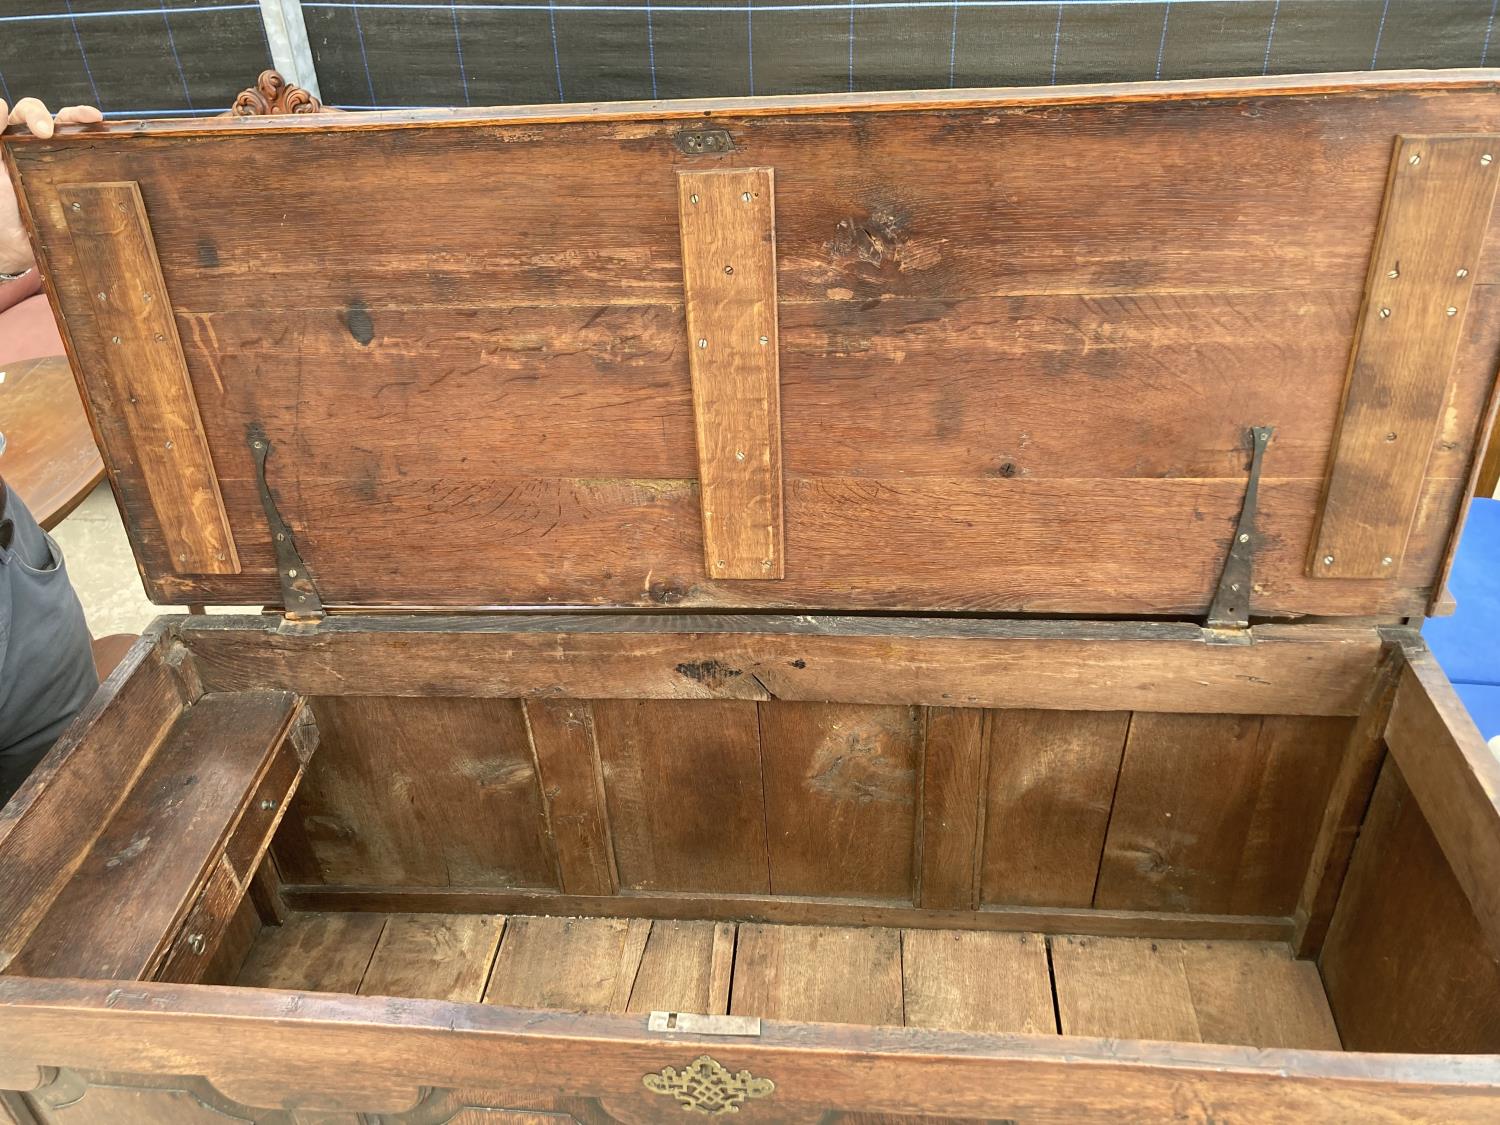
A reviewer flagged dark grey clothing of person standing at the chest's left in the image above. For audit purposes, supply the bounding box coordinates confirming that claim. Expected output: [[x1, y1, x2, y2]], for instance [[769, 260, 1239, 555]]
[[0, 482, 99, 806]]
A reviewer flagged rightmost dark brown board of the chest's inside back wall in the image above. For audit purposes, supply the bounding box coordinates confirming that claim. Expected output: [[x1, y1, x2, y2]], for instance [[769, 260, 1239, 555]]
[[1094, 714, 1349, 915]]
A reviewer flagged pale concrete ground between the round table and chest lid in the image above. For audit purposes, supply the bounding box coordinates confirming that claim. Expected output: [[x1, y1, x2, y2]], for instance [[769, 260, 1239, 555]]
[[53, 485, 240, 638]]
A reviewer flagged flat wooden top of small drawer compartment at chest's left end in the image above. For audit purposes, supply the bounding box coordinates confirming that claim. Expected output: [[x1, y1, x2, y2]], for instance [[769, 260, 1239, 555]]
[[11, 692, 299, 980]]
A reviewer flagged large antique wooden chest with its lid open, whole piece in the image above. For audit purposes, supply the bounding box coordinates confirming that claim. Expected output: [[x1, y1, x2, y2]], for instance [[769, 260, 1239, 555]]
[[0, 72, 1500, 1125]]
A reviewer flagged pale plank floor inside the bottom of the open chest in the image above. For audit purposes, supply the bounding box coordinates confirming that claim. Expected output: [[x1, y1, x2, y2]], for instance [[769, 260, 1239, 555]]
[[237, 912, 1340, 1050]]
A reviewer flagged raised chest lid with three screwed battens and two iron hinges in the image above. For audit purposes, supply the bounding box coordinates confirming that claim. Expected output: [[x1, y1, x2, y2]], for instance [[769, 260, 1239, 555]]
[[5, 72, 1500, 618]]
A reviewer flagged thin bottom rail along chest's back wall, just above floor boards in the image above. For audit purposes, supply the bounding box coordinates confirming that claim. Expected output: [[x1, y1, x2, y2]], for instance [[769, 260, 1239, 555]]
[[285, 885, 1293, 942]]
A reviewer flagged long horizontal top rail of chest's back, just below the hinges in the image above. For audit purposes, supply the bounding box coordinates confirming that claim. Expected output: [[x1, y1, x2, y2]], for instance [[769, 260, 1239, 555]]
[[177, 614, 1382, 717]]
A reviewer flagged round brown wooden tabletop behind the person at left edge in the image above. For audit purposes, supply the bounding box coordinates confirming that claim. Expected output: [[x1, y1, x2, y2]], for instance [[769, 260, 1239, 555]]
[[0, 356, 104, 530]]
